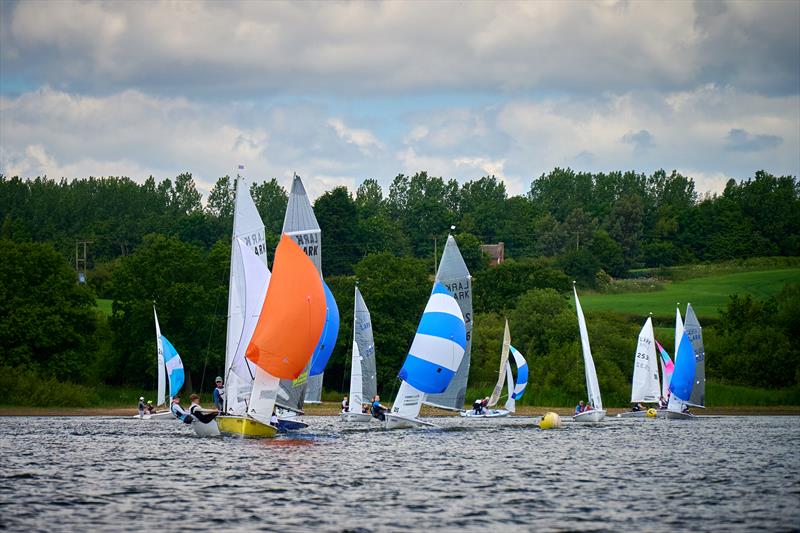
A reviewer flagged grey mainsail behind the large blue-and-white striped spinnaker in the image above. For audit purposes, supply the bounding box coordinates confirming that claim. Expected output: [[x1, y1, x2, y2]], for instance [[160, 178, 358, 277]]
[[425, 235, 472, 411]]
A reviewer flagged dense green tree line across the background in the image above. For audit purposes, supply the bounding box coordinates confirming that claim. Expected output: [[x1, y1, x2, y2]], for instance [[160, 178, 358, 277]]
[[0, 169, 800, 403]]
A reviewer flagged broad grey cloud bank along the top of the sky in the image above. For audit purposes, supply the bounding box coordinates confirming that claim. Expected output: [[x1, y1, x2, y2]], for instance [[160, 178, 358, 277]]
[[0, 0, 800, 95]]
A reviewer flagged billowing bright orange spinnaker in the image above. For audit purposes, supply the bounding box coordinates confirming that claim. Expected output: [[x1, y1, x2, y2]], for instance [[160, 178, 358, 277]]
[[245, 234, 326, 379]]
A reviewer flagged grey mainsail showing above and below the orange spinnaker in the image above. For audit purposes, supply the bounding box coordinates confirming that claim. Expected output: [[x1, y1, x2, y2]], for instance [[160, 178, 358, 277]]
[[277, 174, 322, 411]]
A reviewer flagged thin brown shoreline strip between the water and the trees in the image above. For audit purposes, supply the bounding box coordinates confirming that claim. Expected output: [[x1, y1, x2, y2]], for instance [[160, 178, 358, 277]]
[[0, 402, 800, 418]]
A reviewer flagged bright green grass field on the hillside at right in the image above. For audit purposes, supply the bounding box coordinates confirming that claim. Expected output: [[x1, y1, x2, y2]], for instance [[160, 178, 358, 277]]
[[581, 268, 800, 318]]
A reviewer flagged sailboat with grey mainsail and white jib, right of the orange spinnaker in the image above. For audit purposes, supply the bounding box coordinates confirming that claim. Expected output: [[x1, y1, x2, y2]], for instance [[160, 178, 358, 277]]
[[340, 284, 378, 423]]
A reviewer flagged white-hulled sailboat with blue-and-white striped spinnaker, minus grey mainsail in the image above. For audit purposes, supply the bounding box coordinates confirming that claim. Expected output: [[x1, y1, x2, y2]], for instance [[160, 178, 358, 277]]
[[385, 282, 467, 429]]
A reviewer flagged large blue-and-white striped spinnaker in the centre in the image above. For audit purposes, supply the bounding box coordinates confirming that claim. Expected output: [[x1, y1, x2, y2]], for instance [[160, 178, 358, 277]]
[[399, 282, 467, 394]]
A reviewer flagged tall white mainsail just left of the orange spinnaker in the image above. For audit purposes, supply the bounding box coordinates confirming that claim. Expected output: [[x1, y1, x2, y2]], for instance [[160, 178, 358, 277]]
[[224, 172, 267, 414]]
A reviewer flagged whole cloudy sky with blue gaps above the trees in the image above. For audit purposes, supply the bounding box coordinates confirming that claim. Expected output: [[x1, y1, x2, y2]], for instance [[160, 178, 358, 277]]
[[0, 0, 800, 200]]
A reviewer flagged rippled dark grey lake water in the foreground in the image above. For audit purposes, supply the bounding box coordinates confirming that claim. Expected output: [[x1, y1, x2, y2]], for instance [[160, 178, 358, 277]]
[[0, 417, 800, 532]]
